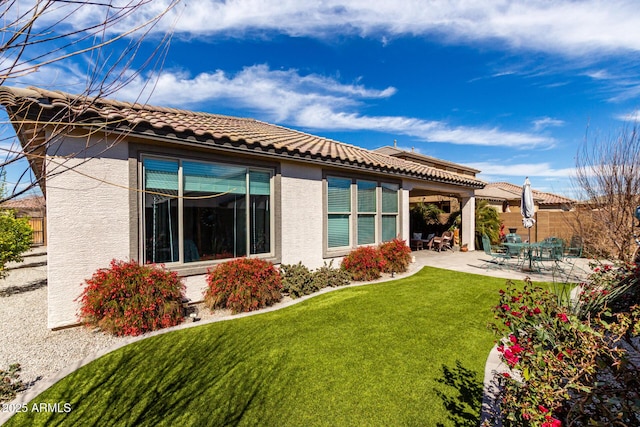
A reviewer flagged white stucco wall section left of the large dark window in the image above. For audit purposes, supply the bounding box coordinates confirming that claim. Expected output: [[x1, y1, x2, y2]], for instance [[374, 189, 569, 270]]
[[47, 138, 130, 329]]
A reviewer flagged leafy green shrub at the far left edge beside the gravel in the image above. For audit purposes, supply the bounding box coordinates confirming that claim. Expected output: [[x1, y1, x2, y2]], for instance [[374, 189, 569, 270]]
[[0, 210, 33, 279]]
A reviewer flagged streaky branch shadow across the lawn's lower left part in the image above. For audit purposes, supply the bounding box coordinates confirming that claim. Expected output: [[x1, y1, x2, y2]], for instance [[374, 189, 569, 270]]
[[7, 322, 285, 426]]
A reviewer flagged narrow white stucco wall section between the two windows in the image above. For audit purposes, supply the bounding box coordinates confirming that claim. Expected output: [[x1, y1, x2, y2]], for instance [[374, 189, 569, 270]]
[[280, 162, 324, 269]]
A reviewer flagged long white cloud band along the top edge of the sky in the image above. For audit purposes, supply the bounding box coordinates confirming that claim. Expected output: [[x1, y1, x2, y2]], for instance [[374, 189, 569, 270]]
[[25, 0, 640, 56]]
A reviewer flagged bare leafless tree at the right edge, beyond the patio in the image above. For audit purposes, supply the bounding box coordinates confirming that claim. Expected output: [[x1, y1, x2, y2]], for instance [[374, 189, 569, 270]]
[[573, 123, 640, 260]]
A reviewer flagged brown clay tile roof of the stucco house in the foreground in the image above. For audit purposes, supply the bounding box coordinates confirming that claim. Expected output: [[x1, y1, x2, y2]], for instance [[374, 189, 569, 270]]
[[0, 87, 485, 188]]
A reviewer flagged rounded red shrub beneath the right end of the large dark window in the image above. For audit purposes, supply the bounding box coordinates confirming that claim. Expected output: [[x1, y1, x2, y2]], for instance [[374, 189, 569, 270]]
[[204, 258, 282, 314]]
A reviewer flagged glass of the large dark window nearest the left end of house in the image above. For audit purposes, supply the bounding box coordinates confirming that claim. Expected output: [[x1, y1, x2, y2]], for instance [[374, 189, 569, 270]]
[[143, 158, 272, 263]]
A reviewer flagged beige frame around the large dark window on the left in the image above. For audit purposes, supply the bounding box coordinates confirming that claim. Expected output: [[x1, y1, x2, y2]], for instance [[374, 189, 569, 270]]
[[137, 152, 278, 269]]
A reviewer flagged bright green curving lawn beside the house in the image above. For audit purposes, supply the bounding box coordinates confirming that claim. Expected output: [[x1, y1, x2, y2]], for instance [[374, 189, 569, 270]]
[[7, 267, 528, 426]]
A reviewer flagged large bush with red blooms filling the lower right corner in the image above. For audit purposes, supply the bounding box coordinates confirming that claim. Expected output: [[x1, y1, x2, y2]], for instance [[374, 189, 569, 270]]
[[491, 274, 640, 427]]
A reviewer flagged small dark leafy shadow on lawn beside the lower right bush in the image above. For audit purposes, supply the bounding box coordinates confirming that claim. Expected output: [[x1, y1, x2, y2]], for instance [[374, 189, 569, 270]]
[[435, 360, 483, 427]]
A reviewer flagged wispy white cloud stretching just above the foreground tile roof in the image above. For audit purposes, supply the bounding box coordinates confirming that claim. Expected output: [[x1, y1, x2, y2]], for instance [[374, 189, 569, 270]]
[[117, 65, 555, 148]]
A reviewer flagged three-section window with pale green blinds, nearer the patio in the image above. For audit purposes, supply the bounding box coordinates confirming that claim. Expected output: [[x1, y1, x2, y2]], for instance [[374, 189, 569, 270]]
[[326, 176, 400, 249]]
